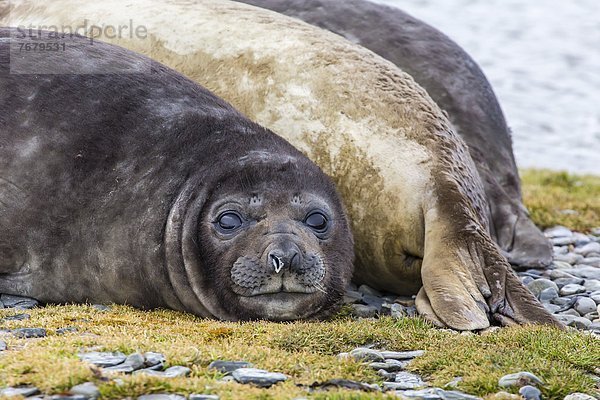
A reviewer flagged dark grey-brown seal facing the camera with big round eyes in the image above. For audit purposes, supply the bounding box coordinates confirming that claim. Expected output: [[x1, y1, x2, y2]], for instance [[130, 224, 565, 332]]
[[0, 28, 353, 320]]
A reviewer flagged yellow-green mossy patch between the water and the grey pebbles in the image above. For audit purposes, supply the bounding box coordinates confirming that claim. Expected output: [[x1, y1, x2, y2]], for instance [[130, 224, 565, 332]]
[[521, 170, 600, 232]]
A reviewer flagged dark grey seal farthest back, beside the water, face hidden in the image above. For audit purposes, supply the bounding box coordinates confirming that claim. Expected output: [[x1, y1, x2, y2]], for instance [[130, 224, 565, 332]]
[[237, 0, 552, 267]]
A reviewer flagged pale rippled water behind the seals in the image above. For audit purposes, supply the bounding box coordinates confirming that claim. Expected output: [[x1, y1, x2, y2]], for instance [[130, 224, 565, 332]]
[[378, 0, 600, 174]]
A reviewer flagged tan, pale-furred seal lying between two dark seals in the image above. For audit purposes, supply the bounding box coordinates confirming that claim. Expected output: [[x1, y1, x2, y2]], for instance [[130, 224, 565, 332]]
[[4, 0, 555, 330]]
